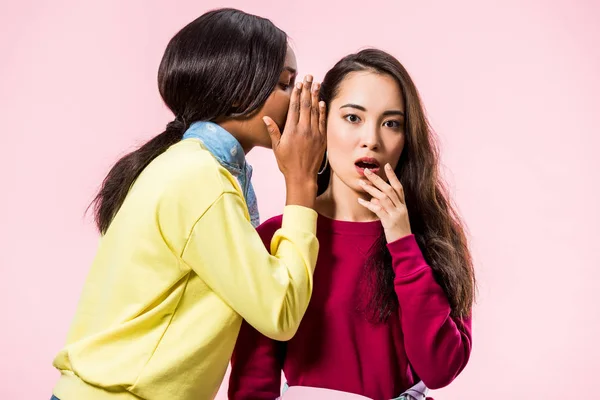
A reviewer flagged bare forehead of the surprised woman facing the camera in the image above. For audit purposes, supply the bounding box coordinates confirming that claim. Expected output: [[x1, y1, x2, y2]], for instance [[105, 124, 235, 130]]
[[333, 71, 404, 111]]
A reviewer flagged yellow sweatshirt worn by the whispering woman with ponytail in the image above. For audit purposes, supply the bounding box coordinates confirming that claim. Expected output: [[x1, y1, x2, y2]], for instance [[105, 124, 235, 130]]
[[54, 139, 318, 400]]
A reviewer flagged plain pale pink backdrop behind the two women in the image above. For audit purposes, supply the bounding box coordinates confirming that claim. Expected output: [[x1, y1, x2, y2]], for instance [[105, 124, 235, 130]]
[[0, 0, 600, 400]]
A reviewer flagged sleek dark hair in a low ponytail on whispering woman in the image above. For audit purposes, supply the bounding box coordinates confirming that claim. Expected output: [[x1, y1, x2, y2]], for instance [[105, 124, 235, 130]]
[[90, 8, 287, 234]]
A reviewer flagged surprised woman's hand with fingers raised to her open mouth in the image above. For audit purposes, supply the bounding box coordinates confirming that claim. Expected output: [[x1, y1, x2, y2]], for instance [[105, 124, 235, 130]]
[[358, 164, 412, 243]]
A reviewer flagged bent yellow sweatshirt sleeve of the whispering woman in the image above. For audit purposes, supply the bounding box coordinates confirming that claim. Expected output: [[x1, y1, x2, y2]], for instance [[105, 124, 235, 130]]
[[182, 192, 319, 340]]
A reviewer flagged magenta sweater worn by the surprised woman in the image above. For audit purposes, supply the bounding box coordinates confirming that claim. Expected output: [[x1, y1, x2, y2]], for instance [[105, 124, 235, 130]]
[[229, 216, 471, 400]]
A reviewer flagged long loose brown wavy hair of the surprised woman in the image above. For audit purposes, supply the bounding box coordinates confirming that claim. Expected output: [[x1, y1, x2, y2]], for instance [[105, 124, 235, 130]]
[[318, 49, 475, 322]]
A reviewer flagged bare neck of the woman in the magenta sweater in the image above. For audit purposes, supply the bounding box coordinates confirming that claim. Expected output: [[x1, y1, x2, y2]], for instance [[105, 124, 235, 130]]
[[316, 171, 378, 222]]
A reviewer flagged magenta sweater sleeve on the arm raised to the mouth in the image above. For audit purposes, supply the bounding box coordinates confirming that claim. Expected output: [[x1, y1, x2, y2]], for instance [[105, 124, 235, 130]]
[[388, 235, 471, 389]]
